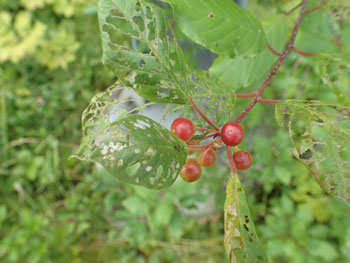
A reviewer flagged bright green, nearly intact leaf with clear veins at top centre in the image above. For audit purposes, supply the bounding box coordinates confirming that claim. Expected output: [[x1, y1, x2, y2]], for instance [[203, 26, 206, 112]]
[[167, 0, 266, 57]]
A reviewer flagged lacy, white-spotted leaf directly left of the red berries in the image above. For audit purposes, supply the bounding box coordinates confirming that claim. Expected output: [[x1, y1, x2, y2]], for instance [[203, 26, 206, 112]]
[[73, 83, 187, 189]]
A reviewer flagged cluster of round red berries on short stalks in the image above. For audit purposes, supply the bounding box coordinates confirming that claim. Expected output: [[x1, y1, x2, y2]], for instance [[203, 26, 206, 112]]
[[171, 113, 252, 182]]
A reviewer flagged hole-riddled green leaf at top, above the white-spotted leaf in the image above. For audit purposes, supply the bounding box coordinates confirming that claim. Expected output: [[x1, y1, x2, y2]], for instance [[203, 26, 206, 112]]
[[98, 0, 188, 104]]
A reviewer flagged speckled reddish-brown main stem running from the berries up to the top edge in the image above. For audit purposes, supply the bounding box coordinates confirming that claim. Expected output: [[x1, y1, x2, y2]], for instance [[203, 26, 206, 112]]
[[235, 0, 308, 123]]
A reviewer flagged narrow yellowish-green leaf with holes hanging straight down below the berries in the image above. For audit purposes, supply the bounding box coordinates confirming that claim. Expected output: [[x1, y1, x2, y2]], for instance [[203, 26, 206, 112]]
[[224, 174, 268, 263]]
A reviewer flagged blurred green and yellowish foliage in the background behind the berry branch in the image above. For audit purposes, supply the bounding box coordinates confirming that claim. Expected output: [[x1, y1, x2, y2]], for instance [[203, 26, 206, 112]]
[[0, 0, 350, 263]]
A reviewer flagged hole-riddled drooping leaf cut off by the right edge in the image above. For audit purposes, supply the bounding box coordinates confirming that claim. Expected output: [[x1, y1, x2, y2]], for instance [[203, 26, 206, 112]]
[[276, 100, 350, 206]]
